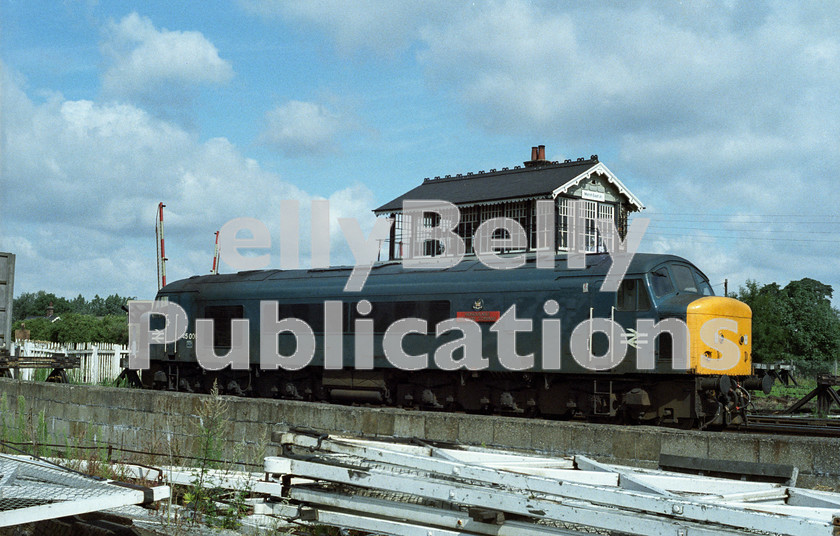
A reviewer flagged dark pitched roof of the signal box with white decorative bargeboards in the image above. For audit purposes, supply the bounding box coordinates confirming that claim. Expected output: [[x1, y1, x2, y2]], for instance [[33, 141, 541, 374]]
[[373, 155, 642, 214]]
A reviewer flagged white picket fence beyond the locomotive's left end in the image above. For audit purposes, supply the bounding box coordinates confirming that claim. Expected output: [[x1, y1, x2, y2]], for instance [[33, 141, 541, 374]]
[[7, 341, 128, 384]]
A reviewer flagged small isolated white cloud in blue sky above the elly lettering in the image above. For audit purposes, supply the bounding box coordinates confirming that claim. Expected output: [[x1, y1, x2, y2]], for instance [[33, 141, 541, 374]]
[[260, 100, 350, 156]]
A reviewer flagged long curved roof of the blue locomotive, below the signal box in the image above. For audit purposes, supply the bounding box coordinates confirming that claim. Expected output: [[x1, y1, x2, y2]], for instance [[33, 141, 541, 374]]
[[163, 253, 687, 292]]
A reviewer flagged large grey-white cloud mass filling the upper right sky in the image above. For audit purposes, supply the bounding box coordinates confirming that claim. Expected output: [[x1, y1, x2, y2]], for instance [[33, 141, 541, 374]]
[[246, 0, 840, 151]]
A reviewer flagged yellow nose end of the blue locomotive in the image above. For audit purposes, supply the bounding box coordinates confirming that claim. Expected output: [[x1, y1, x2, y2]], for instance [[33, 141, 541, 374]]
[[686, 296, 752, 376]]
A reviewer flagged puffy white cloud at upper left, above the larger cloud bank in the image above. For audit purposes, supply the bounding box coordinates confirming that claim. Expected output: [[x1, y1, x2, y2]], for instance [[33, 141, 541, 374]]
[[100, 13, 233, 116]]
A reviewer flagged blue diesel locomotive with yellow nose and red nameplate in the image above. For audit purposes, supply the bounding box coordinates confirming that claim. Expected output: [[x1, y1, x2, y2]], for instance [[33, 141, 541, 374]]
[[142, 254, 768, 427]]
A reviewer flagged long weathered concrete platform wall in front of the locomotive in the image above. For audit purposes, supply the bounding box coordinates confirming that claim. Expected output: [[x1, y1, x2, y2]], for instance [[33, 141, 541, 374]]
[[0, 379, 840, 490]]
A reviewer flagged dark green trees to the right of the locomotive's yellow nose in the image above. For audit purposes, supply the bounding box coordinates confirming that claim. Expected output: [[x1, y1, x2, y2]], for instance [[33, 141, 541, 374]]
[[737, 278, 840, 370]]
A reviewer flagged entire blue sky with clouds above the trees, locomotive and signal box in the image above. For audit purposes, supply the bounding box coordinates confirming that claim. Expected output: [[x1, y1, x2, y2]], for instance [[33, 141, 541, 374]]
[[0, 0, 840, 305]]
